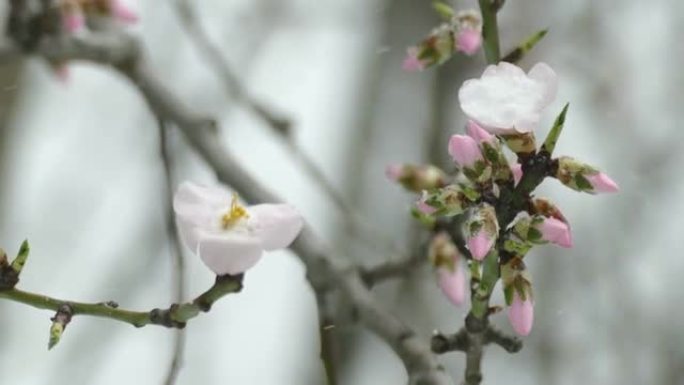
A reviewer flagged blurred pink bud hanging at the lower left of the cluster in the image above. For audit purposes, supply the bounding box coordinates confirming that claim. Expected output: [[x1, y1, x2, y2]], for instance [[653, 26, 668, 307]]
[[428, 232, 466, 306]]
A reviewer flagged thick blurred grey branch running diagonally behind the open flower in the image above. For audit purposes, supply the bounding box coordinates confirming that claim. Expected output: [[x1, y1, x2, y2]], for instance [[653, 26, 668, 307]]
[[12, 31, 452, 385]]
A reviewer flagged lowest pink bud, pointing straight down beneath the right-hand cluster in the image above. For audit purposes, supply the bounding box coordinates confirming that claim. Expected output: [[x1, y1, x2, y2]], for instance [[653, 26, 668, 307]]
[[501, 258, 534, 336]]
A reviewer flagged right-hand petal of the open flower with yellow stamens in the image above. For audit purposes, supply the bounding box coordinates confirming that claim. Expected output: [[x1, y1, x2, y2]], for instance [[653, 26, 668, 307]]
[[248, 204, 304, 250]]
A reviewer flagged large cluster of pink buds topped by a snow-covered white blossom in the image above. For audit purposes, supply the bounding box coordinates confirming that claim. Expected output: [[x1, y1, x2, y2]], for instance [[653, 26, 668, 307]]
[[388, 62, 618, 335]]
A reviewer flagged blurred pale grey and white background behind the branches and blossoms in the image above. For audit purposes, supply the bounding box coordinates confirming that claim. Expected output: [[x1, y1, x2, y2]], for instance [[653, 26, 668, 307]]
[[0, 0, 684, 385]]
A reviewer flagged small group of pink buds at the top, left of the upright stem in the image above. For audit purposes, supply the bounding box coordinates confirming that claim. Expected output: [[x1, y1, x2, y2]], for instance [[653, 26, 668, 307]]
[[403, 3, 482, 72]]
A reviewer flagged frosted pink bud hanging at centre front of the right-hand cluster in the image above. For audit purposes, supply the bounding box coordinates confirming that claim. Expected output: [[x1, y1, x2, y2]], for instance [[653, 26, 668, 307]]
[[464, 203, 499, 261]]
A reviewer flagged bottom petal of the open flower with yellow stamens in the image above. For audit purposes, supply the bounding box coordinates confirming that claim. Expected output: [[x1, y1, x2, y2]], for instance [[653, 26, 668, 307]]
[[197, 233, 263, 275]]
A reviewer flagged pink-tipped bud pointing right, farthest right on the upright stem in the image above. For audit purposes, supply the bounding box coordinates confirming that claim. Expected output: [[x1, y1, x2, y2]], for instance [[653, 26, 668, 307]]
[[556, 156, 620, 194]]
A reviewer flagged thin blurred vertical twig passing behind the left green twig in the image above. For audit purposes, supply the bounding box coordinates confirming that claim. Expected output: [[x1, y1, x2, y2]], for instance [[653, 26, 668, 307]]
[[158, 119, 186, 385]]
